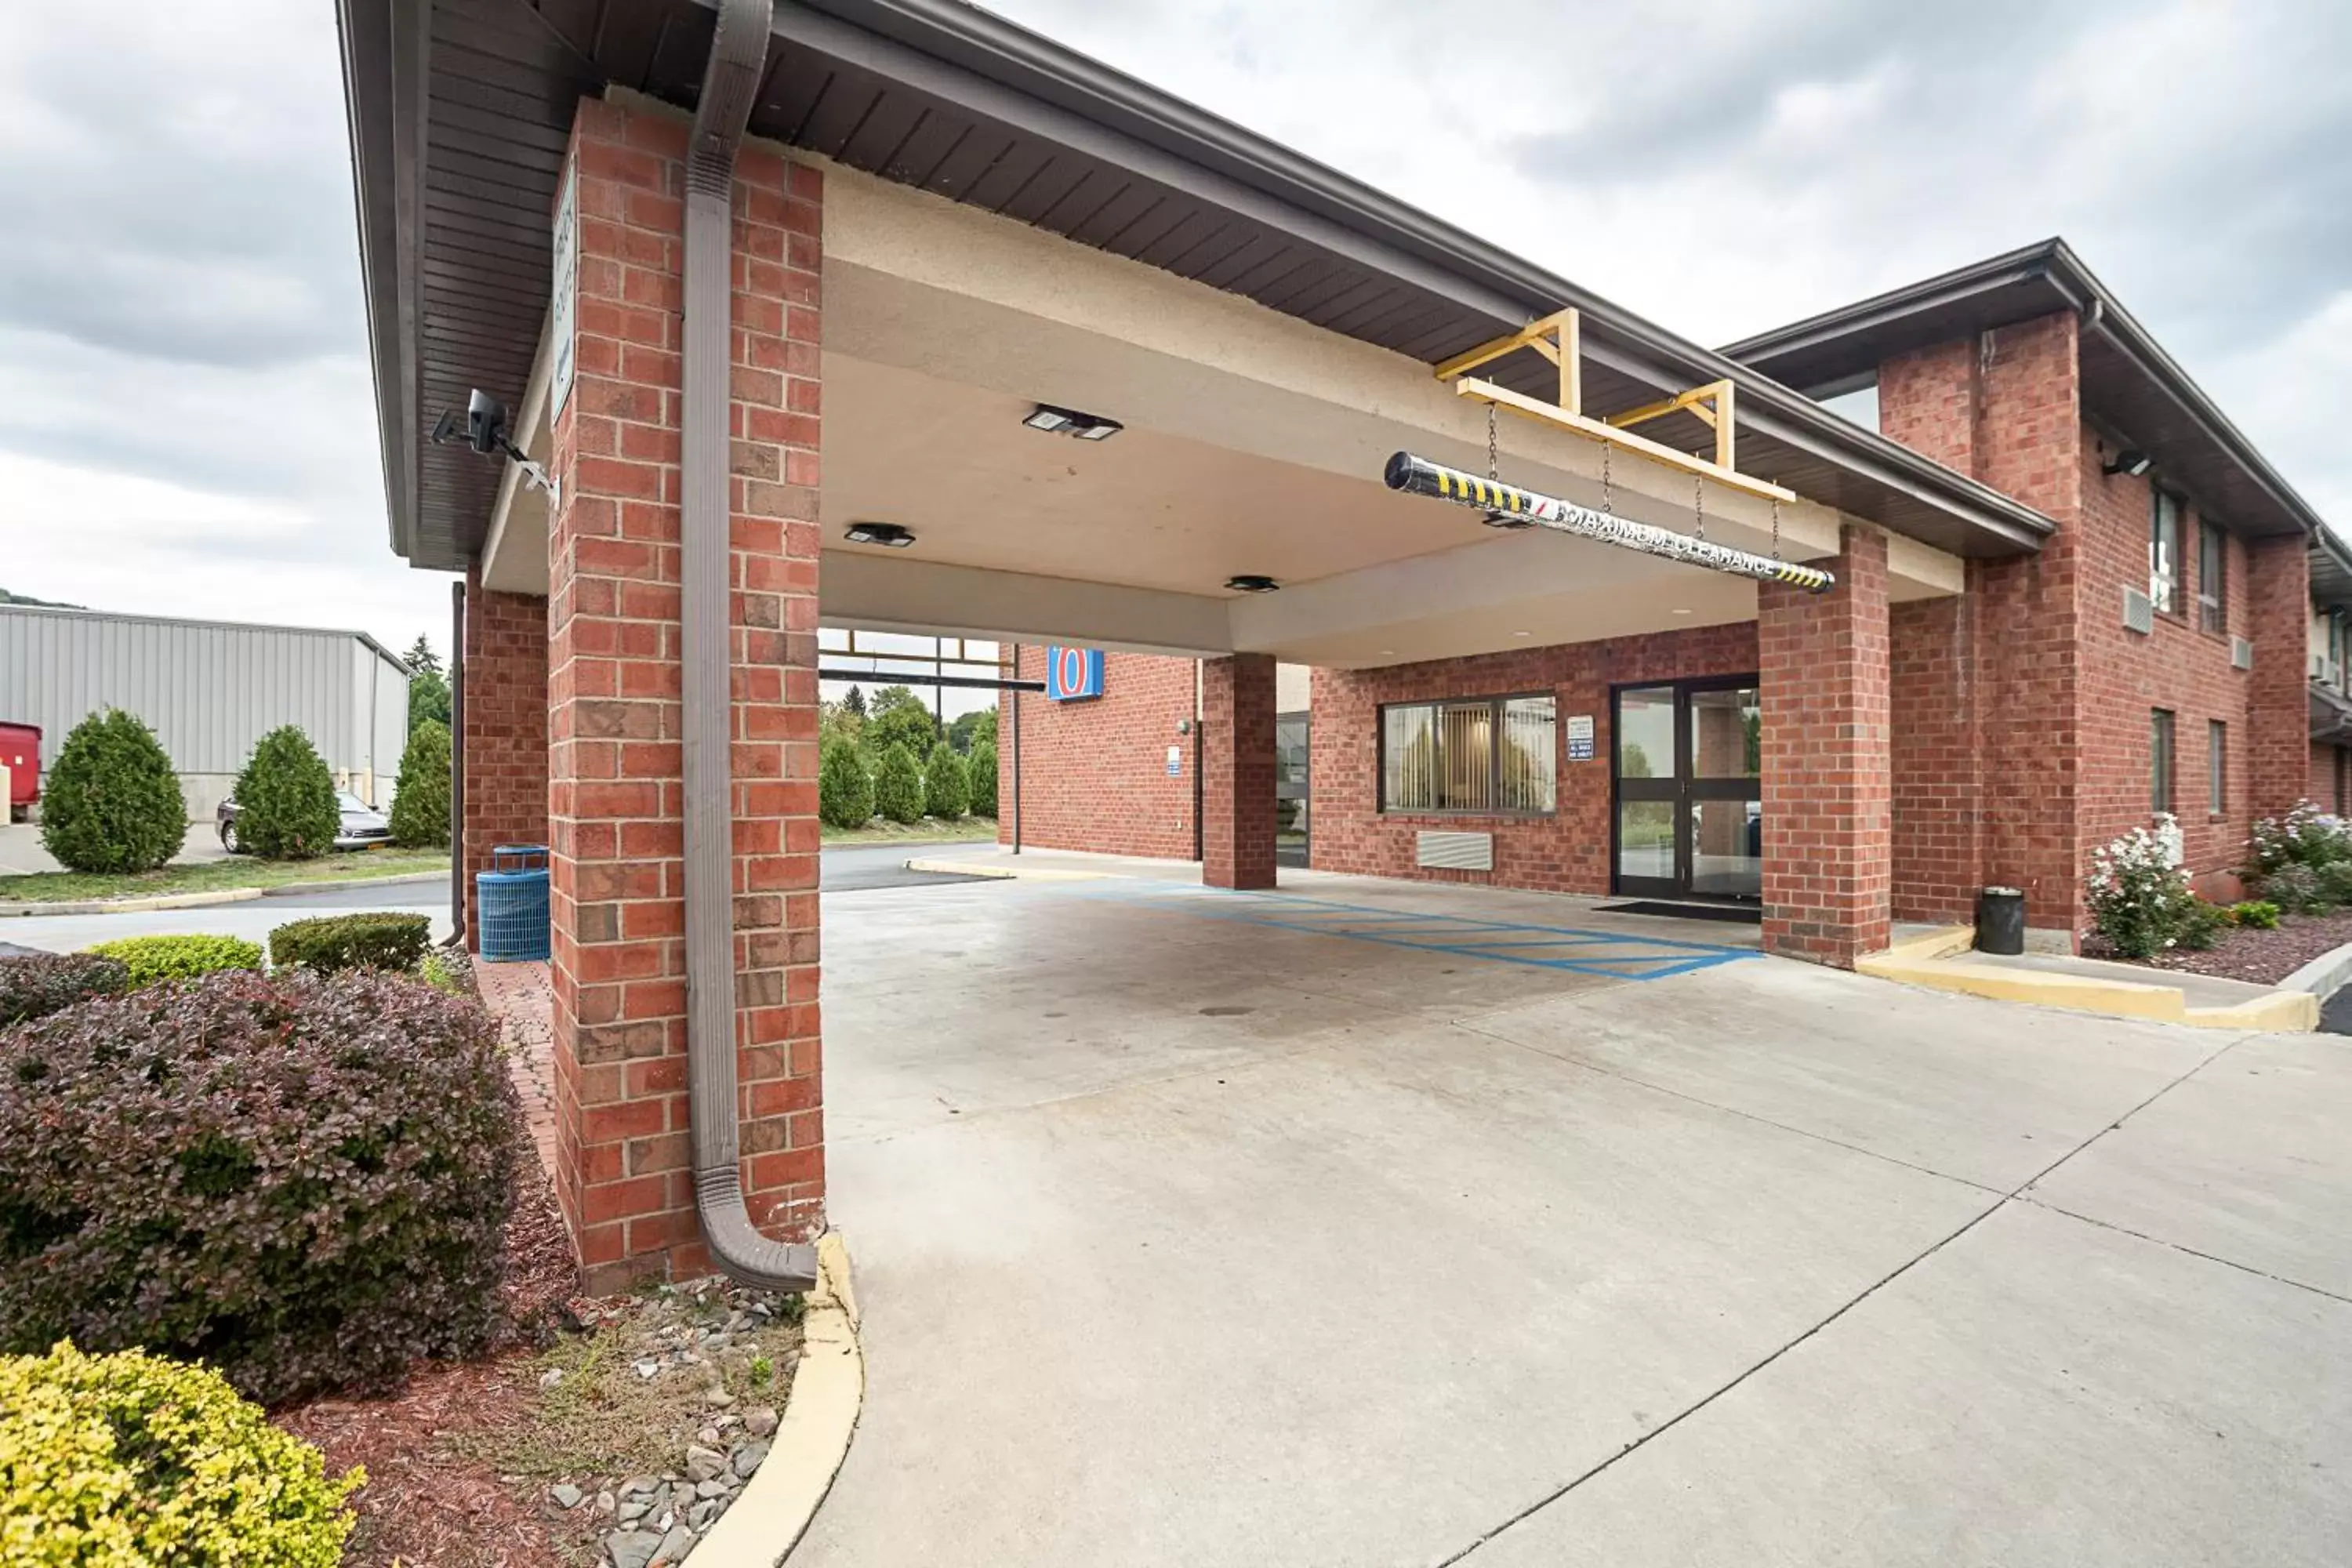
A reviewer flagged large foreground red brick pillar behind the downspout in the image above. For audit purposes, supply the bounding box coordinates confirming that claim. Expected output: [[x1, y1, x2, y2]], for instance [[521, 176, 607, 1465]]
[[548, 101, 823, 1288]]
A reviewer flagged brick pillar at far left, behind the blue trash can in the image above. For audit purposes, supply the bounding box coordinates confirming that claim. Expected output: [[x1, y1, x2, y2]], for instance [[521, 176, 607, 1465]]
[[456, 572, 548, 952]]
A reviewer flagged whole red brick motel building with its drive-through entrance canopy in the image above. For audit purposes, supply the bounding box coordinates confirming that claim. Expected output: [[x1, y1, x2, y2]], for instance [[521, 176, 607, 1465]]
[[339, 0, 2352, 1286]]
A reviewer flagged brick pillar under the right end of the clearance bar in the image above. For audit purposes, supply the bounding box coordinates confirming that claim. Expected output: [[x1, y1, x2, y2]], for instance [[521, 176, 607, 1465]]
[[1757, 524, 1893, 968]]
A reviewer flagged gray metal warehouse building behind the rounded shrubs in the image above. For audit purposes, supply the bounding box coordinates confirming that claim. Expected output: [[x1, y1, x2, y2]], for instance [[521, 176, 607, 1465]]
[[0, 604, 409, 820]]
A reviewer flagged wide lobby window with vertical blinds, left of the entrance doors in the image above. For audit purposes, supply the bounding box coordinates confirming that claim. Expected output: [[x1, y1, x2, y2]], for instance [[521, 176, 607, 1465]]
[[1381, 696, 1559, 815]]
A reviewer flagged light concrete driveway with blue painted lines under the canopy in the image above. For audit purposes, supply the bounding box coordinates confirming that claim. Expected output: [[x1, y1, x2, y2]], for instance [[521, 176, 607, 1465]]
[[779, 872, 2352, 1568]]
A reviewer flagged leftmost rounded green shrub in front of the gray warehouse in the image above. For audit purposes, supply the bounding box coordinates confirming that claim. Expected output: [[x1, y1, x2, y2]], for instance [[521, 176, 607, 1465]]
[[40, 708, 188, 872]]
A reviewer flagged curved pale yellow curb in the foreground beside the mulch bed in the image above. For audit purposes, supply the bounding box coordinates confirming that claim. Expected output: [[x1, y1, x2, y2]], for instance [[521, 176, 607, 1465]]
[[694, 1229, 866, 1568]]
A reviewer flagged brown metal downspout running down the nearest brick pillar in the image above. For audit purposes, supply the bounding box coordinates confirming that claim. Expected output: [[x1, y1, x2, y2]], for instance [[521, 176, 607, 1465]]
[[677, 0, 816, 1290]]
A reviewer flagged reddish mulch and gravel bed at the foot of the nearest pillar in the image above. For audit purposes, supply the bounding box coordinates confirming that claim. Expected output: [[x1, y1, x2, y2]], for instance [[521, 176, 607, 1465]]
[[273, 952, 800, 1568]]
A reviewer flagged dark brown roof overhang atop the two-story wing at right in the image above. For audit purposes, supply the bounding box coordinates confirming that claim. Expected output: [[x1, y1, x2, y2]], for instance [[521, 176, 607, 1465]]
[[1724, 240, 2324, 550]]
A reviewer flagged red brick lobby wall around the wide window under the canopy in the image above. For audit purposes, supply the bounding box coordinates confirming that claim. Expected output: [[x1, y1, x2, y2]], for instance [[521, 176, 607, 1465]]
[[1310, 621, 1771, 893]]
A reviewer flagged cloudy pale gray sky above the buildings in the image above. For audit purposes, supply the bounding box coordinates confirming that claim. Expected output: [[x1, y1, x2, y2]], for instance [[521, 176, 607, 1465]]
[[0, 0, 2352, 647]]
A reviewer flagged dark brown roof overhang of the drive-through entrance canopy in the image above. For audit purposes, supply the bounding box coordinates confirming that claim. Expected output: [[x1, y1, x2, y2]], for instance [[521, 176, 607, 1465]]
[[339, 0, 2053, 569]]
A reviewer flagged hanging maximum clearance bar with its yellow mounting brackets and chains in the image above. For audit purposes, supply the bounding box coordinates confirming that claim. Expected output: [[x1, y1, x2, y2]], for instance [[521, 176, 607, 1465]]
[[1385, 310, 1837, 593]]
